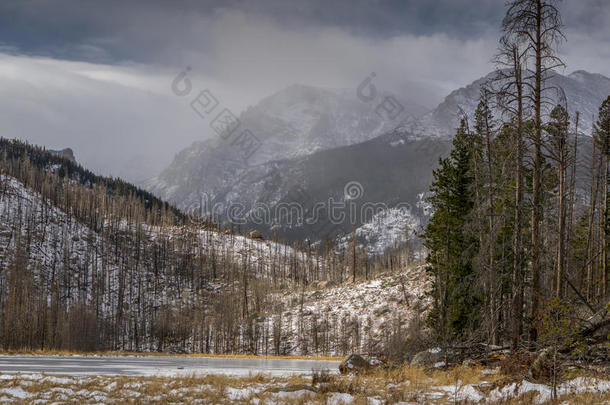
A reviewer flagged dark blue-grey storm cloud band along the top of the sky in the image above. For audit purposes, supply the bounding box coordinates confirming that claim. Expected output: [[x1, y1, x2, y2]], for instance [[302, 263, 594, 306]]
[[0, 0, 501, 63]]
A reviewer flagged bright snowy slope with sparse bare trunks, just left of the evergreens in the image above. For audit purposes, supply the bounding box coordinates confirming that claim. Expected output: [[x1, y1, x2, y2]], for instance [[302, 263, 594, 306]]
[[268, 266, 431, 355]]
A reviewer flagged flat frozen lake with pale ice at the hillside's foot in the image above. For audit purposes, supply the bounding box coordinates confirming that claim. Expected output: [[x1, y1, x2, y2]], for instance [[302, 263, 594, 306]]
[[0, 355, 339, 376]]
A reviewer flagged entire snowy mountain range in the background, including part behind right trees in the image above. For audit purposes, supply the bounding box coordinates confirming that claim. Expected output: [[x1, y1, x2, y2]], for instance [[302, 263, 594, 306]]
[[145, 71, 610, 253]]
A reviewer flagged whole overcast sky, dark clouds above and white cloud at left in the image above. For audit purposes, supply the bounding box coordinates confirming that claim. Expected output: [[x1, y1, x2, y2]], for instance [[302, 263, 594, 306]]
[[0, 0, 610, 180]]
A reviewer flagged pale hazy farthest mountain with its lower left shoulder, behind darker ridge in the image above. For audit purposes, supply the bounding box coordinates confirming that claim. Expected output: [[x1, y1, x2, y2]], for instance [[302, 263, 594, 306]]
[[144, 85, 427, 202]]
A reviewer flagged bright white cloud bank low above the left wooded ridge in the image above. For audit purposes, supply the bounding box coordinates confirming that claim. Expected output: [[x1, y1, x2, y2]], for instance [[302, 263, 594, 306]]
[[0, 54, 208, 181]]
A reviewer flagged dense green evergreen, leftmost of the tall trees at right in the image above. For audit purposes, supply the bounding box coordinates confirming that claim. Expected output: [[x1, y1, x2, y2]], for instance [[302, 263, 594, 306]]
[[424, 121, 481, 344]]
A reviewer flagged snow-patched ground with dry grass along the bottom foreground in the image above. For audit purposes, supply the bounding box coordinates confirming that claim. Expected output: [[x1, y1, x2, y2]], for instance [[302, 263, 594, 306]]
[[0, 370, 610, 405]]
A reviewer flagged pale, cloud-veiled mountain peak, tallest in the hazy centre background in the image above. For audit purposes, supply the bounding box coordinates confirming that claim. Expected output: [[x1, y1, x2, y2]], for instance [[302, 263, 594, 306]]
[[226, 84, 425, 164]]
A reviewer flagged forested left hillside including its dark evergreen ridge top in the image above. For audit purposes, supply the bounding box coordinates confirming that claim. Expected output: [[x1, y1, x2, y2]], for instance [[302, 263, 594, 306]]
[[0, 141, 415, 354]]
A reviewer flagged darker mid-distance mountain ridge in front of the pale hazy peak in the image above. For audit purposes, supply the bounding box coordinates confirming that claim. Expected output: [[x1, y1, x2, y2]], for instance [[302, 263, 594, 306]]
[[145, 131, 451, 249]]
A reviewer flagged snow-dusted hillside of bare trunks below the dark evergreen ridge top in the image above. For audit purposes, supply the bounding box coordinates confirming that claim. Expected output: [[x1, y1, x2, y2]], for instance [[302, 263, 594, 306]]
[[0, 172, 429, 354]]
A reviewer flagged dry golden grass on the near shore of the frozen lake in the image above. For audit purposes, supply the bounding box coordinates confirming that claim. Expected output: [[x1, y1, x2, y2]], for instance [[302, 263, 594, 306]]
[[0, 366, 610, 405]]
